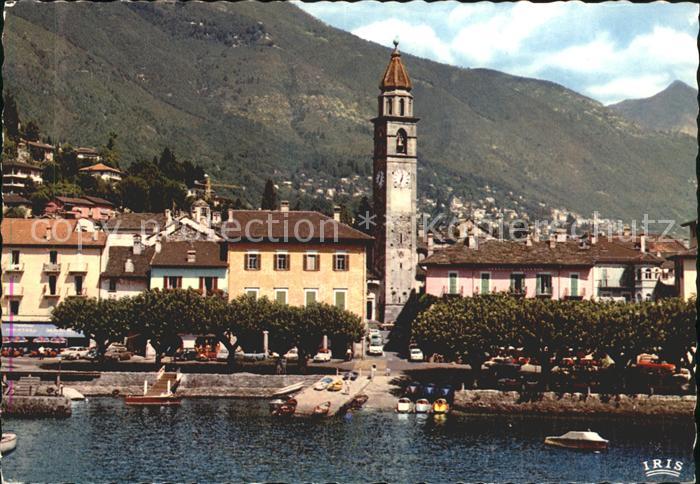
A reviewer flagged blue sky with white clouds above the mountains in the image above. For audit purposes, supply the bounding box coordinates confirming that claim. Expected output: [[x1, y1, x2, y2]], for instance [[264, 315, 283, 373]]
[[297, 1, 700, 104]]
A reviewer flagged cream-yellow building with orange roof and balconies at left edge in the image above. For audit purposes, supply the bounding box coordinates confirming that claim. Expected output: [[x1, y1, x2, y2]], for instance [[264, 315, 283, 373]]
[[2, 219, 106, 337]]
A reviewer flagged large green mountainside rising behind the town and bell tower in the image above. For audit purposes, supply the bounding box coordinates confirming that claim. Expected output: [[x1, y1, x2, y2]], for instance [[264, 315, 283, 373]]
[[4, 2, 696, 219]]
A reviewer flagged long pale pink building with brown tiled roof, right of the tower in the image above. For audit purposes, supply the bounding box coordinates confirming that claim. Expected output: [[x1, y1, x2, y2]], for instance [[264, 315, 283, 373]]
[[421, 234, 663, 300]]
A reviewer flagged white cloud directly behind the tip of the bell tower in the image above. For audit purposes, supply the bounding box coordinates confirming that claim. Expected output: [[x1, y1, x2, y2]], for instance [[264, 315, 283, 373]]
[[352, 18, 454, 64]]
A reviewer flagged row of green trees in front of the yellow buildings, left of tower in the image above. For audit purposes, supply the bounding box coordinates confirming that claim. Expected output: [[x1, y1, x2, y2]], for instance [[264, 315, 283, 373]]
[[52, 289, 363, 365]]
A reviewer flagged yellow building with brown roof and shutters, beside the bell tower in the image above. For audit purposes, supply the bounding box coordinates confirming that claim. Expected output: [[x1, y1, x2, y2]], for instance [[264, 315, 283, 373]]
[[221, 207, 372, 318]]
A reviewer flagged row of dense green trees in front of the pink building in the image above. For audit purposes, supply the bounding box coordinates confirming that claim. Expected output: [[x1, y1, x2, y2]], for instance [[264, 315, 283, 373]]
[[411, 294, 697, 384]]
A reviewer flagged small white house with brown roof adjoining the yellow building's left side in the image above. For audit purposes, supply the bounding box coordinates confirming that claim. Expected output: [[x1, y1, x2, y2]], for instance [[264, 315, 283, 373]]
[[150, 240, 229, 294]]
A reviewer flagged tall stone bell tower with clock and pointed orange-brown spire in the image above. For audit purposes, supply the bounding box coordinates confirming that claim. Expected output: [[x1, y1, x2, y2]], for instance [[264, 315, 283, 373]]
[[372, 41, 418, 322]]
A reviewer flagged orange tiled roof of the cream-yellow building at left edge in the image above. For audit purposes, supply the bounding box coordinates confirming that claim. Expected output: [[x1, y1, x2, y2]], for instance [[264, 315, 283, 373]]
[[2, 218, 107, 247]]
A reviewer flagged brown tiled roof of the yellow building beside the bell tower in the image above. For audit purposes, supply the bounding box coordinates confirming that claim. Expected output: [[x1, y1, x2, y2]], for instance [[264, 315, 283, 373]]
[[220, 210, 372, 243]]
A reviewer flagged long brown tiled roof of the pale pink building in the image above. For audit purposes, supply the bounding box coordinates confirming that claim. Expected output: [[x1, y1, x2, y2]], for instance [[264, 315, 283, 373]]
[[421, 240, 662, 266]]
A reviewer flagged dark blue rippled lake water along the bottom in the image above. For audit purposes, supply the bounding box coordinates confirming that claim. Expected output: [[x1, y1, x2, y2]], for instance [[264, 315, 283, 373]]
[[2, 398, 694, 483]]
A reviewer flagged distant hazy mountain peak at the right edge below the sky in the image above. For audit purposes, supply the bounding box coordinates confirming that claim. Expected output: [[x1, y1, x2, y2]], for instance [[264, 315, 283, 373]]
[[608, 81, 698, 137]]
